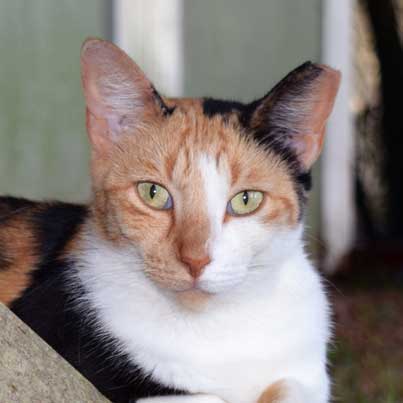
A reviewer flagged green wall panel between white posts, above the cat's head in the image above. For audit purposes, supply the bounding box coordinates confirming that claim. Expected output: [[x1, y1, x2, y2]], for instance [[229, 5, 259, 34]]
[[183, 0, 321, 100]]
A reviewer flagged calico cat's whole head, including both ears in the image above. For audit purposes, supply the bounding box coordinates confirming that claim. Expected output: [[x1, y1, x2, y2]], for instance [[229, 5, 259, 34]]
[[81, 39, 340, 306]]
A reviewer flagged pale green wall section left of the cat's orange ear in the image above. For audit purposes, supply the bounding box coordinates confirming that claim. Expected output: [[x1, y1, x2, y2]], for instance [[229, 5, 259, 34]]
[[0, 0, 107, 201]]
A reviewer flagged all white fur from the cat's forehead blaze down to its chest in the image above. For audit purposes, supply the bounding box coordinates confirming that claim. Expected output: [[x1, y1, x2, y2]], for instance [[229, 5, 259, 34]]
[[74, 155, 329, 403]]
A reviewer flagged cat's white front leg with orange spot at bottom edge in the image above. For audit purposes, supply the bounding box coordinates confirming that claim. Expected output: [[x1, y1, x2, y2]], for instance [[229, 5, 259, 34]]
[[257, 379, 327, 403]]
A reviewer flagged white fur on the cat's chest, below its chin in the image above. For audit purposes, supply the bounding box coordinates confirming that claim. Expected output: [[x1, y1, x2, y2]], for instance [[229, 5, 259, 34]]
[[78, 238, 329, 403]]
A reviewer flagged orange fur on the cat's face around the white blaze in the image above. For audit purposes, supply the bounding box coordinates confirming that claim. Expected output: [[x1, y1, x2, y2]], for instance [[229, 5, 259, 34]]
[[92, 99, 299, 300]]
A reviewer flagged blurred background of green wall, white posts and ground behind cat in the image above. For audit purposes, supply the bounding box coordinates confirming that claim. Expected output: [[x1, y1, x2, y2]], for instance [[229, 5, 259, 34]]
[[0, 0, 403, 403]]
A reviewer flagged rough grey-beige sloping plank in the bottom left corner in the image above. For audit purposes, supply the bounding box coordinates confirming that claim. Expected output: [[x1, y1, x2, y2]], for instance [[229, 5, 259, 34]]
[[0, 304, 109, 403]]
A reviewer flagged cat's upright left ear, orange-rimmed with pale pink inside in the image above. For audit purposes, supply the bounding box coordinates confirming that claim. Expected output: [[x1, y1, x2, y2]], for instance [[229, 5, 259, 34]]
[[81, 38, 166, 152]]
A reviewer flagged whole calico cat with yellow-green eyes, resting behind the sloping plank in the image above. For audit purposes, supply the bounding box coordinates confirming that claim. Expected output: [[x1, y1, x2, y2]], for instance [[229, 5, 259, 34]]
[[0, 39, 340, 403]]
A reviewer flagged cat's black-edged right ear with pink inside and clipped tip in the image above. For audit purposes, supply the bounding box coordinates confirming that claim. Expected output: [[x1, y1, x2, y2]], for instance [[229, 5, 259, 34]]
[[250, 62, 340, 170]]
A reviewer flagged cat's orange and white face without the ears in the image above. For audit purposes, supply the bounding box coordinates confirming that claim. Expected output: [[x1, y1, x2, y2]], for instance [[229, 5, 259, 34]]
[[90, 101, 300, 293]]
